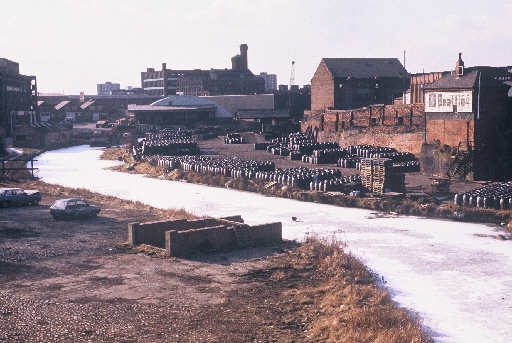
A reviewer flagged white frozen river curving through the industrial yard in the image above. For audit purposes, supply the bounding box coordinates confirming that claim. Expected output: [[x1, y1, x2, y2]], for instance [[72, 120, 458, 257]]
[[37, 146, 512, 343]]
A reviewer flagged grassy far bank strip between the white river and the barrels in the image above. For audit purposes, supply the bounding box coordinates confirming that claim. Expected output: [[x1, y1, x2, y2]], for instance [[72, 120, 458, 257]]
[[101, 148, 512, 233]]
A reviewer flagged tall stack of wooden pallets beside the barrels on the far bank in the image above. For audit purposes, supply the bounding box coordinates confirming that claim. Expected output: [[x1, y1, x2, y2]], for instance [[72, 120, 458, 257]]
[[361, 158, 405, 194]]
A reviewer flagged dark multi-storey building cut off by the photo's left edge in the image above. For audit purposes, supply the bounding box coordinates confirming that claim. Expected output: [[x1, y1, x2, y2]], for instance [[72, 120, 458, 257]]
[[0, 58, 37, 145]]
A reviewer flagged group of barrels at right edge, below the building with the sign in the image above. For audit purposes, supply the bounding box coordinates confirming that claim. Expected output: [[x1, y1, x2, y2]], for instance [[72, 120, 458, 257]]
[[454, 181, 512, 210]]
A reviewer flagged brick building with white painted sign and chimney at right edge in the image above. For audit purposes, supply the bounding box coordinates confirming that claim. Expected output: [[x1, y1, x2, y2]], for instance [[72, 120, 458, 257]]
[[423, 54, 512, 179]]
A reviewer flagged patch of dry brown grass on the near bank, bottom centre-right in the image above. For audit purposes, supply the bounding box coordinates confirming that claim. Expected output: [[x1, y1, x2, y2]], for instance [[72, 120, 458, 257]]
[[271, 238, 432, 343]]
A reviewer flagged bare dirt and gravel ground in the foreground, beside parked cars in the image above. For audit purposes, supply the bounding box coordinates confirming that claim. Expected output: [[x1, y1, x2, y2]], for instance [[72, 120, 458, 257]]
[[0, 183, 304, 342]]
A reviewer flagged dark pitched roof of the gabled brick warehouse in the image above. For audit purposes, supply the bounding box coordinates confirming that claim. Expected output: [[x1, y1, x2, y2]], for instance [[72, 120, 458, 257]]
[[322, 58, 408, 79]]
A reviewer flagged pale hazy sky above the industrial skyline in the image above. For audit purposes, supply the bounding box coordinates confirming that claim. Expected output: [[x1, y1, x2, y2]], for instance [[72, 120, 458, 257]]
[[0, 0, 512, 94]]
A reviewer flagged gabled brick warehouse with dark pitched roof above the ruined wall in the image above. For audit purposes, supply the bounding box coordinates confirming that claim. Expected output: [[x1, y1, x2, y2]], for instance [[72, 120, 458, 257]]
[[311, 58, 409, 110]]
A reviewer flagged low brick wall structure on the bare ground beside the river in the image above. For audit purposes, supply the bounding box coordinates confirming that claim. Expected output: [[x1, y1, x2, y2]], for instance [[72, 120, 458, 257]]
[[128, 216, 282, 256]]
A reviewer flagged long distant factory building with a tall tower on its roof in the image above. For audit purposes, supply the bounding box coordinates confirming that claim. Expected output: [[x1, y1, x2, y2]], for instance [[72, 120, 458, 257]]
[[141, 44, 265, 96]]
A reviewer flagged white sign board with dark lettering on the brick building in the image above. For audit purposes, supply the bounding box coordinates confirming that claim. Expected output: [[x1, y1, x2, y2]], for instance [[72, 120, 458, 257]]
[[425, 91, 473, 113]]
